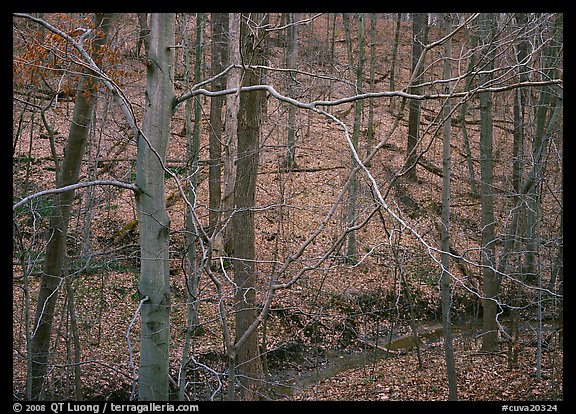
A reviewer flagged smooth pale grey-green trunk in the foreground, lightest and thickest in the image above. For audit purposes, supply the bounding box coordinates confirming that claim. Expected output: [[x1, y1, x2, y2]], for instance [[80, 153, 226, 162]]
[[136, 13, 175, 401]]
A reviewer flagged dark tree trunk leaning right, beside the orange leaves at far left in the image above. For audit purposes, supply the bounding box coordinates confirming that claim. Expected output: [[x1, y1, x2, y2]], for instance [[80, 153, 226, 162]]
[[28, 13, 112, 400]]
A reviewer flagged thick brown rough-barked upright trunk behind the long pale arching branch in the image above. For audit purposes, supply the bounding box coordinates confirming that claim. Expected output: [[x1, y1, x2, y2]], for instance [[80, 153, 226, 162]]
[[229, 13, 265, 400]]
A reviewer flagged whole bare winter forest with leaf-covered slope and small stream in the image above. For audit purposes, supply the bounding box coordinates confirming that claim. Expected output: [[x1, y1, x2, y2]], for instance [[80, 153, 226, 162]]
[[12, 13, 564, 401]]
